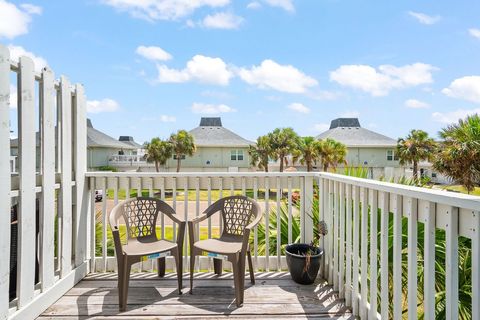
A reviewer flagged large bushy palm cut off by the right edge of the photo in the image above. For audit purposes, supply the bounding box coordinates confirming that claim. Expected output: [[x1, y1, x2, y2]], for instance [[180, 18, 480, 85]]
[[433, 114, 480, 193]]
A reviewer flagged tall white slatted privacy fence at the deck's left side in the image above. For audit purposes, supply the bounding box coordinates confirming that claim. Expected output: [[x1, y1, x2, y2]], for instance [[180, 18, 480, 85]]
[[0, 45, 91, 319]]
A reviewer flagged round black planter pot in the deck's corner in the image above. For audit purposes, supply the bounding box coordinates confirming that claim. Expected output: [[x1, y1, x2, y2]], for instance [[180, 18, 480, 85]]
[[285, 243, 323, 284]]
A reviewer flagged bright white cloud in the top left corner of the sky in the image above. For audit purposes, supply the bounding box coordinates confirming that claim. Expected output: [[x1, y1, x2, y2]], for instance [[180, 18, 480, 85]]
[[0, 0, 42, 39]]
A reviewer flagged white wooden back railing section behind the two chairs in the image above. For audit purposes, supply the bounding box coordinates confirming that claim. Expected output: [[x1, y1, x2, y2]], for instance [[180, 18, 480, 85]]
[[87, 172, 315, 272]]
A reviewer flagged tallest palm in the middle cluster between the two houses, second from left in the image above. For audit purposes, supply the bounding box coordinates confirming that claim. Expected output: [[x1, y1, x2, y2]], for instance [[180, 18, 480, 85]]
[[268, 128, 300, 172]]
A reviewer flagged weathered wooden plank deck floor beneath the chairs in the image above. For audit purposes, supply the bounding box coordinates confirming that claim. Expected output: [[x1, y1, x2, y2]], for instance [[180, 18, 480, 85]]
[[38, 272, 354, 320]]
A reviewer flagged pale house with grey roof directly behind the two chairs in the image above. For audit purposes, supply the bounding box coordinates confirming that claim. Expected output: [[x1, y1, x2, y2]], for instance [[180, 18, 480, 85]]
[[167, 117, 254, 171]]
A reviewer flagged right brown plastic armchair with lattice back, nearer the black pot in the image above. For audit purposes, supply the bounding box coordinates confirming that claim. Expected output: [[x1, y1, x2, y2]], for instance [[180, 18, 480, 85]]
[[188, 196, 262, 307]]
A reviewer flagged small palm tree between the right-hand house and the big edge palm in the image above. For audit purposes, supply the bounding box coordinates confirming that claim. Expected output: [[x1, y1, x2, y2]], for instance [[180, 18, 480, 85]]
[[396, 130, 436, 182]]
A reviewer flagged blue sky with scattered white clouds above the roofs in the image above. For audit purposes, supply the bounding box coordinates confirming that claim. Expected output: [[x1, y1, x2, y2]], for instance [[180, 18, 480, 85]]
[[0, 0, 480, 142]]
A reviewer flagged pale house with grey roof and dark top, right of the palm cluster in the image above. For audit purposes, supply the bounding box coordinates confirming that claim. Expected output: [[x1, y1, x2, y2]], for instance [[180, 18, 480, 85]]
[[317, 118, 405, 179]]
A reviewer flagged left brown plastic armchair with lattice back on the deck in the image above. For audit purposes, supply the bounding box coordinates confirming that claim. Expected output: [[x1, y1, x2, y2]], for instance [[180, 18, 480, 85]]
[[109, 197, 185, 311]]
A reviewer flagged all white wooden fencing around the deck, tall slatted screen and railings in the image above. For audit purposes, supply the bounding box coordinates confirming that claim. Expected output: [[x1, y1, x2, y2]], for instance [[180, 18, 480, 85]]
[[0, 41, 480, 319]]
